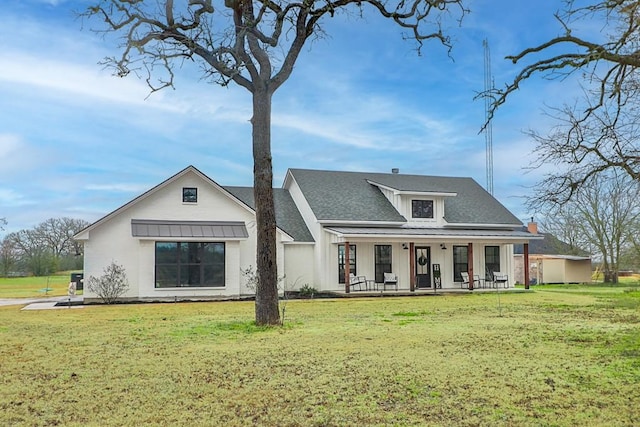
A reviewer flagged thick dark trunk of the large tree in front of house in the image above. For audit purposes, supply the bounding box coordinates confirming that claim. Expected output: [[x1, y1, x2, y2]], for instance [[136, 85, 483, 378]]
[[251, 88, 280, 325]]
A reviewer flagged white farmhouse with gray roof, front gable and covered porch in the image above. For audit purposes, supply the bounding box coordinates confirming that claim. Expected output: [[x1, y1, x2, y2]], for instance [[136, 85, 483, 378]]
[[75, 166, 537, 301]]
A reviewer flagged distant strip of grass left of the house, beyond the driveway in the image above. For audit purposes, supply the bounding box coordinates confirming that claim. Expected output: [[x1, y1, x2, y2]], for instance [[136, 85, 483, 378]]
[[0, 271, 82, 298]]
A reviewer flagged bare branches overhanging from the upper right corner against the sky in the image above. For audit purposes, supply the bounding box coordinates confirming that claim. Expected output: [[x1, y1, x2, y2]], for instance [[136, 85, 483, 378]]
[[484, 0, 640, 202]]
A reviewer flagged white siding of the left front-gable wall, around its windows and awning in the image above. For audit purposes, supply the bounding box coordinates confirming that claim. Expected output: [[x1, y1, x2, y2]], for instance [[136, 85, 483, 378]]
[[84, 172, 292, 300]]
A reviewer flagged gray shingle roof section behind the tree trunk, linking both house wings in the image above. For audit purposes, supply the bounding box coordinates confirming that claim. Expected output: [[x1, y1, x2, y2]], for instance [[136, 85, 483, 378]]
[[223, 186, 314, 242]]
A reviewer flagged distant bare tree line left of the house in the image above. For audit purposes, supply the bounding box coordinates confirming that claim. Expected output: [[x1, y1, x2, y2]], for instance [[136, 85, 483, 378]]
[[0, 217, 89, 277]]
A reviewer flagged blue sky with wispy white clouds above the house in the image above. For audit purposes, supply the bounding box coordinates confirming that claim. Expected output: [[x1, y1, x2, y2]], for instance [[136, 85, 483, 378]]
[[0, 0, 592, 233]]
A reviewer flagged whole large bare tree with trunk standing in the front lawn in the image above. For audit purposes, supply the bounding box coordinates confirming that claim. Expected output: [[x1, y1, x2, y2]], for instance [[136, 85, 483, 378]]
[[82, 0, 466, 325]]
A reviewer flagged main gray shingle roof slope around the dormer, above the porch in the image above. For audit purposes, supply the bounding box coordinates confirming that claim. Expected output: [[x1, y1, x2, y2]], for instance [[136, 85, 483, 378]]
[[289, 169, 522, 226]]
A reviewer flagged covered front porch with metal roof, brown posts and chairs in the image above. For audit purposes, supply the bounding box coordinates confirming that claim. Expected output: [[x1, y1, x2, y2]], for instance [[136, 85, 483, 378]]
[[325, 227, 536, 294]]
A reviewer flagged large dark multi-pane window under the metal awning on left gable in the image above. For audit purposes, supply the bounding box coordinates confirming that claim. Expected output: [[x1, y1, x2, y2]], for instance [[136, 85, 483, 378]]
[[156, 242, 225, 288]]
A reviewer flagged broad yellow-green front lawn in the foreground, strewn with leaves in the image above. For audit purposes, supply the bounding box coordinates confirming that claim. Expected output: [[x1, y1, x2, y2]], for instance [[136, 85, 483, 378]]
[[0, 286, 640, 426]]
